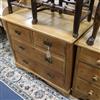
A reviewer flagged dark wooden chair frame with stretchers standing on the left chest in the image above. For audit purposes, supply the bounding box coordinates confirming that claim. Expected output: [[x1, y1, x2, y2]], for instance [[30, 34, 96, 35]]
[[7, 0, 94, 38]]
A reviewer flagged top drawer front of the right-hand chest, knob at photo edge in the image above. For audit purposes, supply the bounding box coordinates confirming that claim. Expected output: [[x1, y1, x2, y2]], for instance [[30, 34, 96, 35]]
[[80, 48, 100, 68]]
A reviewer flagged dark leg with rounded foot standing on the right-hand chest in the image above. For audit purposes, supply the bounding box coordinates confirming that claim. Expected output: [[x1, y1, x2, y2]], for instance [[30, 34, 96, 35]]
[[87, 0, 100, 45]]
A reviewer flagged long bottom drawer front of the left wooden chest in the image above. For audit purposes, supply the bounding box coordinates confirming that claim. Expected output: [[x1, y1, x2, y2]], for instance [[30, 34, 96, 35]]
[[15, 52, 64, 87]]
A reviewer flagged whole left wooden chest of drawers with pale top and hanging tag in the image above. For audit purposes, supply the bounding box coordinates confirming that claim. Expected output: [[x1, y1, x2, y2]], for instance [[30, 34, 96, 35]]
[[3, 9, 91, 95]]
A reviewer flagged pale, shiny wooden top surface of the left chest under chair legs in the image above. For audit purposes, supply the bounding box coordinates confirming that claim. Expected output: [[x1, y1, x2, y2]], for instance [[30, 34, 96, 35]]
[[2, 9, 92, 43]]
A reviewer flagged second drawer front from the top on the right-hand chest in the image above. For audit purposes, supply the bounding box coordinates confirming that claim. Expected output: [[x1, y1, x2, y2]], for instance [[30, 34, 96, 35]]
[[78, 62, 100, 86]]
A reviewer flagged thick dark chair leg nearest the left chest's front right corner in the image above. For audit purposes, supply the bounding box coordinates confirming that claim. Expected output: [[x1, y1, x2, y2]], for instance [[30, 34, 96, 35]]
[[73, 0, 83, 38]]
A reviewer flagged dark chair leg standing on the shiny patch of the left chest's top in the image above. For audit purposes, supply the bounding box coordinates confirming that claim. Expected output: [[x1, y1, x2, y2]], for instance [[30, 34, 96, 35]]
[[31, 0, 38, 24]]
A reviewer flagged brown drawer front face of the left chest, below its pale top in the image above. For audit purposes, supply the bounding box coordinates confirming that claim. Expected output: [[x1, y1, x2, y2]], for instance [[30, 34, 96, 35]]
[[7, 23, 73, 94]]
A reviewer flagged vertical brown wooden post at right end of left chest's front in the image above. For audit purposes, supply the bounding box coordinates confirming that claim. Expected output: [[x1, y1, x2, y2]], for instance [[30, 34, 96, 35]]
[[65, 43, 75, 91]]
